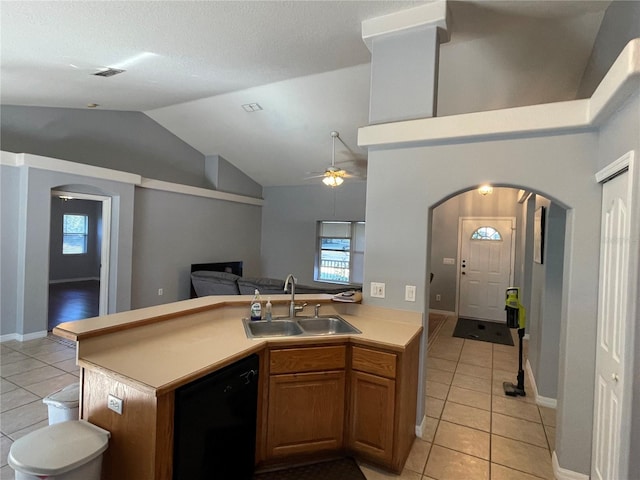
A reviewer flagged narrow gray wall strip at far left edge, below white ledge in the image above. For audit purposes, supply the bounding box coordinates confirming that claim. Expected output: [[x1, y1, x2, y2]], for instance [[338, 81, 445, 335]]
[[0, 165, 20, 335]]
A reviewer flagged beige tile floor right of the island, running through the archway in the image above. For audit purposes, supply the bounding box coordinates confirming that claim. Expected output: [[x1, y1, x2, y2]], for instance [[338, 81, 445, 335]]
[[361, 317, 555, 480]]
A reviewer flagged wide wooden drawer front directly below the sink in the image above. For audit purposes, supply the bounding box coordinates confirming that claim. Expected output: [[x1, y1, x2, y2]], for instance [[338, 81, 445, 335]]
[[269, 345, 346, 375]]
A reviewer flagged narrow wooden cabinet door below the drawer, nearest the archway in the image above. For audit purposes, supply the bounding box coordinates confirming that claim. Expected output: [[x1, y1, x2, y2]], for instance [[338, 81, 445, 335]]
[[349, 371, 396, 464]]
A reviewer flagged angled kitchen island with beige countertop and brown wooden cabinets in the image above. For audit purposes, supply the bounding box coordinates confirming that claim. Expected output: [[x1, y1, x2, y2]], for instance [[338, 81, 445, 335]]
[[54, 295, 422, 479]]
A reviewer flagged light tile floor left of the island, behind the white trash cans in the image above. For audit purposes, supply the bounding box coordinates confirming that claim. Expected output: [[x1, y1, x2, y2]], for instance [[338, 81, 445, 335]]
[[0, 336, 79, 480]]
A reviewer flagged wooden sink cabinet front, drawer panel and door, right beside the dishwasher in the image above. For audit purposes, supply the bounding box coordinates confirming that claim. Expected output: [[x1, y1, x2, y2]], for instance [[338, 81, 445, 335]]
[[263, 345, 346, 461]]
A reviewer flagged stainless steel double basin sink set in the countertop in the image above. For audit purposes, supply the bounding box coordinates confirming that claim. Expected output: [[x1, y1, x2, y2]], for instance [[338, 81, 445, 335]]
[[242, 315, 362, 338]]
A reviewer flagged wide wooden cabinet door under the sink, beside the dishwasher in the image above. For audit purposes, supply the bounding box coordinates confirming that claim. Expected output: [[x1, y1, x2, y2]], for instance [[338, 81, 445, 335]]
[[267, 371, 345, 458]]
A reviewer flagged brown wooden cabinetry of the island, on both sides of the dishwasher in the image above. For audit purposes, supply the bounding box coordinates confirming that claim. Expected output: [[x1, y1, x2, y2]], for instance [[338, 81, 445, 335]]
[[81, 335, 420, 480]]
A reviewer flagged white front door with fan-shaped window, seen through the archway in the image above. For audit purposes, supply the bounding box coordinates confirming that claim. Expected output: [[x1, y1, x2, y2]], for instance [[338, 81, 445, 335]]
[[458, 218, 515, 322]]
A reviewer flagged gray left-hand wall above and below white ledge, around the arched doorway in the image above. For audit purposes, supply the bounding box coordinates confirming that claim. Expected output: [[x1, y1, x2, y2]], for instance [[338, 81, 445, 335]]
[[0, 105, 261, 334]]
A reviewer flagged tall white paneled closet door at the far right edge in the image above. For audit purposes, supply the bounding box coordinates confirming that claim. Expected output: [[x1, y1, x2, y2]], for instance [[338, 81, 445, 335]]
[[591, 162, 637, 480]]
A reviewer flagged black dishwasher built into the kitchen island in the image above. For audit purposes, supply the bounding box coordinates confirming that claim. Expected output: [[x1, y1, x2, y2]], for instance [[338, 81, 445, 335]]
[[173, 355, 259, 480]]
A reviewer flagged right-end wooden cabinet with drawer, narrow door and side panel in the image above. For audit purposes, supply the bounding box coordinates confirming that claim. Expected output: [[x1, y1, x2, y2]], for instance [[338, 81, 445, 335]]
[[347, 339, 419, 473]]
